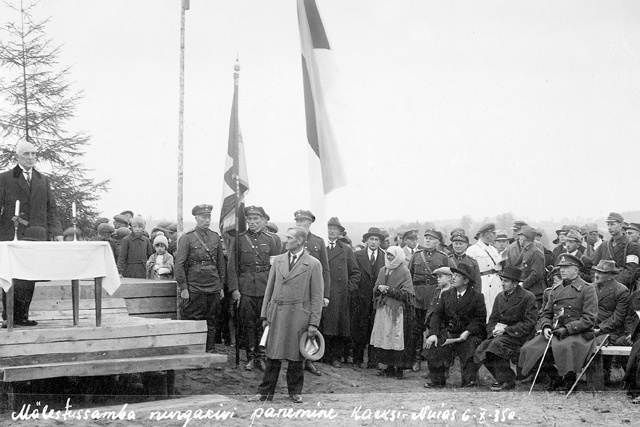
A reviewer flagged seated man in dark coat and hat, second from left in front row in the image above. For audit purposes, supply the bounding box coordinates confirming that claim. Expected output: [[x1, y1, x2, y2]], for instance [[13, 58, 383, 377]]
[[474, 266, 538, 391]]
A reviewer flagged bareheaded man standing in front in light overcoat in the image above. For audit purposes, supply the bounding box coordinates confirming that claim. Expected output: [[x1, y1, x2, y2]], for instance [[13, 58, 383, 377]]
[[253, 227, 324, 403]]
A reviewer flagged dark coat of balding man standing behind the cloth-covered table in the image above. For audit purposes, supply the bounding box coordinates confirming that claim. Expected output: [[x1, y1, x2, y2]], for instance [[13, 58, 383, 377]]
[[0, 165, 62, 242]]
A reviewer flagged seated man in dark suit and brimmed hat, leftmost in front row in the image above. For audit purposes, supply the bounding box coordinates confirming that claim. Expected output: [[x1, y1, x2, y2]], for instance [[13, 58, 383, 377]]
[[424, 264, 487, 388]]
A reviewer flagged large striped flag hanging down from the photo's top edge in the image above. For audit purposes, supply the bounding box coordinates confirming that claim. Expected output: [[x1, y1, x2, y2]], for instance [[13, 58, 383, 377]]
[[298, 0, 346, 199]]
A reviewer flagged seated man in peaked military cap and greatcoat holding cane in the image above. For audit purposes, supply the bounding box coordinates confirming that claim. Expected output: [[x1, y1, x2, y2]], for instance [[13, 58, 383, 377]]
[[518, 254, 598, 391]]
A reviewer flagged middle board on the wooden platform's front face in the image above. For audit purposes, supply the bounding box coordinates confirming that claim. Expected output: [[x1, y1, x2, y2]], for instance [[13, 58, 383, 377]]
[[0, 332, 207, 357]]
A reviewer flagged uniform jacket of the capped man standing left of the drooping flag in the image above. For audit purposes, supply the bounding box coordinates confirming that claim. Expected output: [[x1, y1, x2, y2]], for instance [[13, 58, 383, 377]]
[[175, 227, 227, 293]]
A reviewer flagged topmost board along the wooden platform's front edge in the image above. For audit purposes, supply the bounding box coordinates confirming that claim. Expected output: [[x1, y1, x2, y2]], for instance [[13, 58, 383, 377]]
[[0, 317, 207, 348]]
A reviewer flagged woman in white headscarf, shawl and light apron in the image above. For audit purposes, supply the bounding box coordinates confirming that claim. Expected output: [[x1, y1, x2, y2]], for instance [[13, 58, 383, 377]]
[[369, 246, 414, 379]]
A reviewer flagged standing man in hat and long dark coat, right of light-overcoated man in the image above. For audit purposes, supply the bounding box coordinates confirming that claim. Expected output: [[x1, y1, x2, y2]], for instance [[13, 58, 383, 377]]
[[320, 217, 360, 368]]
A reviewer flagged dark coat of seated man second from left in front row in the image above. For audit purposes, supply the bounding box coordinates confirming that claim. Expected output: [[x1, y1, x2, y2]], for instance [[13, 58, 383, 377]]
[[474, 286, 538, 363]]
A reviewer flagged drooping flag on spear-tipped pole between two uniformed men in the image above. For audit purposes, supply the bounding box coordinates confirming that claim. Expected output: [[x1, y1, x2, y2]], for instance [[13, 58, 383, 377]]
[[220, 65, 249, 237]]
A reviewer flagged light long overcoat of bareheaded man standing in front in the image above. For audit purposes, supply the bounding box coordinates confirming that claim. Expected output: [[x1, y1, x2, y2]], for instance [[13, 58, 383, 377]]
[[261, 250, 324, 361]]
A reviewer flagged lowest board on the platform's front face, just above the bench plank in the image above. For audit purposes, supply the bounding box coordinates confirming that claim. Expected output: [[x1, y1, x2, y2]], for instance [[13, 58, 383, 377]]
[[0, 340, 206, 366]]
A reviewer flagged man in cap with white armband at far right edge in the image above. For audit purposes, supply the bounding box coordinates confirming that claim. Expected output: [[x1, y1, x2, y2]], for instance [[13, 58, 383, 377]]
[[592, 212, 640, 291]]
